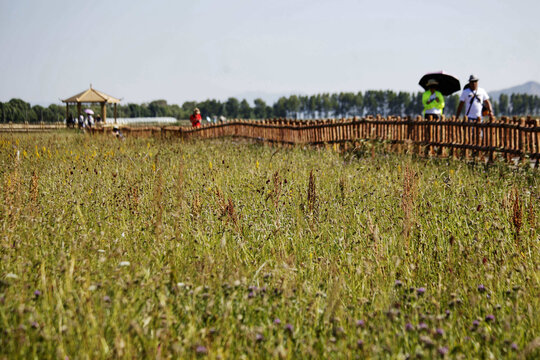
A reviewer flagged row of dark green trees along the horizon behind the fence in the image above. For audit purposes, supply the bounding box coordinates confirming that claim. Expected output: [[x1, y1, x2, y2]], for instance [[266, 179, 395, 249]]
[[0, 90, 540, 123]]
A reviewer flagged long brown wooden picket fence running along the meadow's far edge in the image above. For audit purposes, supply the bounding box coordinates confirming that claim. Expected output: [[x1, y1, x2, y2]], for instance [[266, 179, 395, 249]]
[[97, 117, 540, 163]]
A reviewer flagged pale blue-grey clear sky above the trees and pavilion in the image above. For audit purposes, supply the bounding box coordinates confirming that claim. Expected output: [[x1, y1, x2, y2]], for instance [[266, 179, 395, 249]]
[[0, 0, 540, 104]]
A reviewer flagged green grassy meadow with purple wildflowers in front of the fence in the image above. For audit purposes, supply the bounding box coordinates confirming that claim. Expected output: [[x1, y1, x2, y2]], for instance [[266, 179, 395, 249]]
[[0, 132, 540, 359]]
